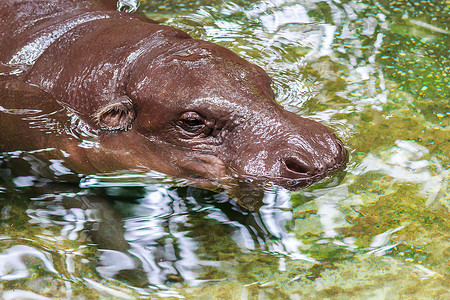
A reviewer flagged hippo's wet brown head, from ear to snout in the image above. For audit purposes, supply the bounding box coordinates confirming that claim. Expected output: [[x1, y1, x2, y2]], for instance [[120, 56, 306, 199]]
[[91, 40, 347, 197]]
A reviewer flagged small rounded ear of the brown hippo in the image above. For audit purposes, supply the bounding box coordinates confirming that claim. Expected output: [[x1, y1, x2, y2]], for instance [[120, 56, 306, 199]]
[[93, 97, 136, 130]]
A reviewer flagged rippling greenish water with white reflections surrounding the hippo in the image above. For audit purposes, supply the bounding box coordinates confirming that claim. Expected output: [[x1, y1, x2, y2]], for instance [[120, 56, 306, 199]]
[[0, 0, 450, 299]]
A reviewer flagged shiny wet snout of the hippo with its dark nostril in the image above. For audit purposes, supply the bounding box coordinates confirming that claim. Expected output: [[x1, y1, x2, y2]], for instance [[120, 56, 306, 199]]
[[231, 122, 348, 190]]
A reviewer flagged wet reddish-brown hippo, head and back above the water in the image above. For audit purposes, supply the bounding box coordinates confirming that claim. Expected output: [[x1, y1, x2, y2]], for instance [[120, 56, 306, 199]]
[[0, 0, 347, 199]]
